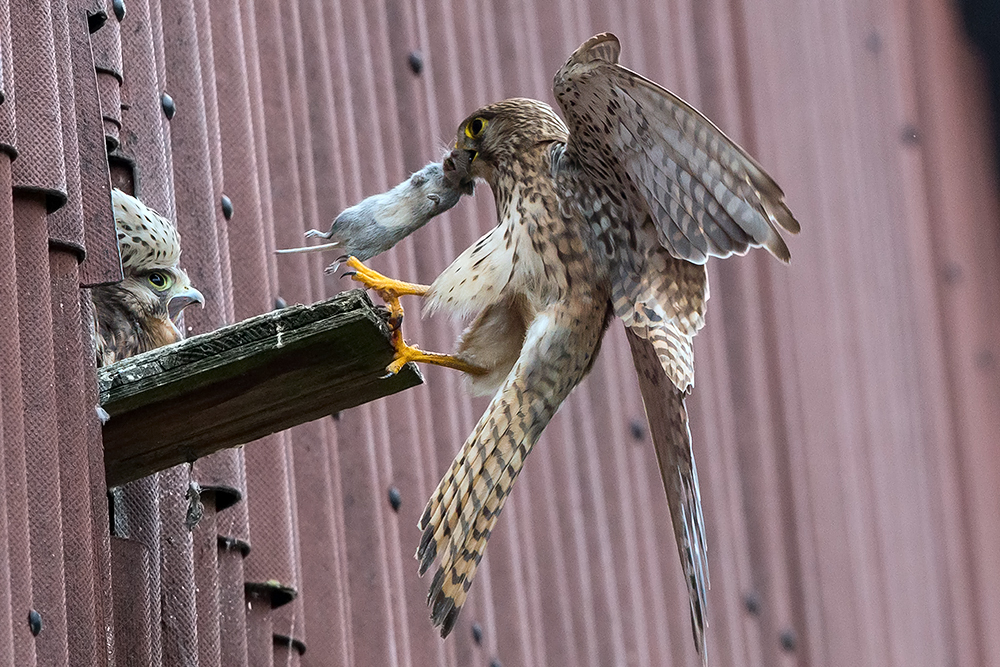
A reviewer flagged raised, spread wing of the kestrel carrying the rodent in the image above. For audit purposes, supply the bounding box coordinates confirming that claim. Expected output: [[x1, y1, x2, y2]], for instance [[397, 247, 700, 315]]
[[554, 33, 799, 264]]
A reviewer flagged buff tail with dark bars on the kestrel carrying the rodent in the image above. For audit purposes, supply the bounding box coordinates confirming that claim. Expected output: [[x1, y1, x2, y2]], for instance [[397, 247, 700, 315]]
[[416, 301, 607, 637]]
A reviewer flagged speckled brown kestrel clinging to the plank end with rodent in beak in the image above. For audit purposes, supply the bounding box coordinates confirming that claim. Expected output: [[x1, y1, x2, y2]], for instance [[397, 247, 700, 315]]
[[349, 33, 799, 661]]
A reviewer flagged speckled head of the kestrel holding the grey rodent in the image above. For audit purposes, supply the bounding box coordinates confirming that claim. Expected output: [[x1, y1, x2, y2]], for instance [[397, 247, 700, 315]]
[[446, 97, 569, 185]]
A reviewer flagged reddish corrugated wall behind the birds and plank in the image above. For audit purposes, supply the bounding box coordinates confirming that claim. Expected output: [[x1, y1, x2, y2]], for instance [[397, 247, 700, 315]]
[[0, 0, 1000, 667]]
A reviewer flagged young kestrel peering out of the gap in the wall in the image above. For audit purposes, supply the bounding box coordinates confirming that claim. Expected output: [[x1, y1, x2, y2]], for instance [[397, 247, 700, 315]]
[[91, 188, 205, 366]]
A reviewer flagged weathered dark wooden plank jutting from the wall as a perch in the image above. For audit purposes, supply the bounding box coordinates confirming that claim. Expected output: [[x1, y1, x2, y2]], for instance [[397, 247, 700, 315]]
[[99, 290, 423, 486]]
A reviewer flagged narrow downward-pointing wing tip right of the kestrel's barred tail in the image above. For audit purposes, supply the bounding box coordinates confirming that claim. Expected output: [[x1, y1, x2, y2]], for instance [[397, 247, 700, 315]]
[[626, 329, 709, 665]]
